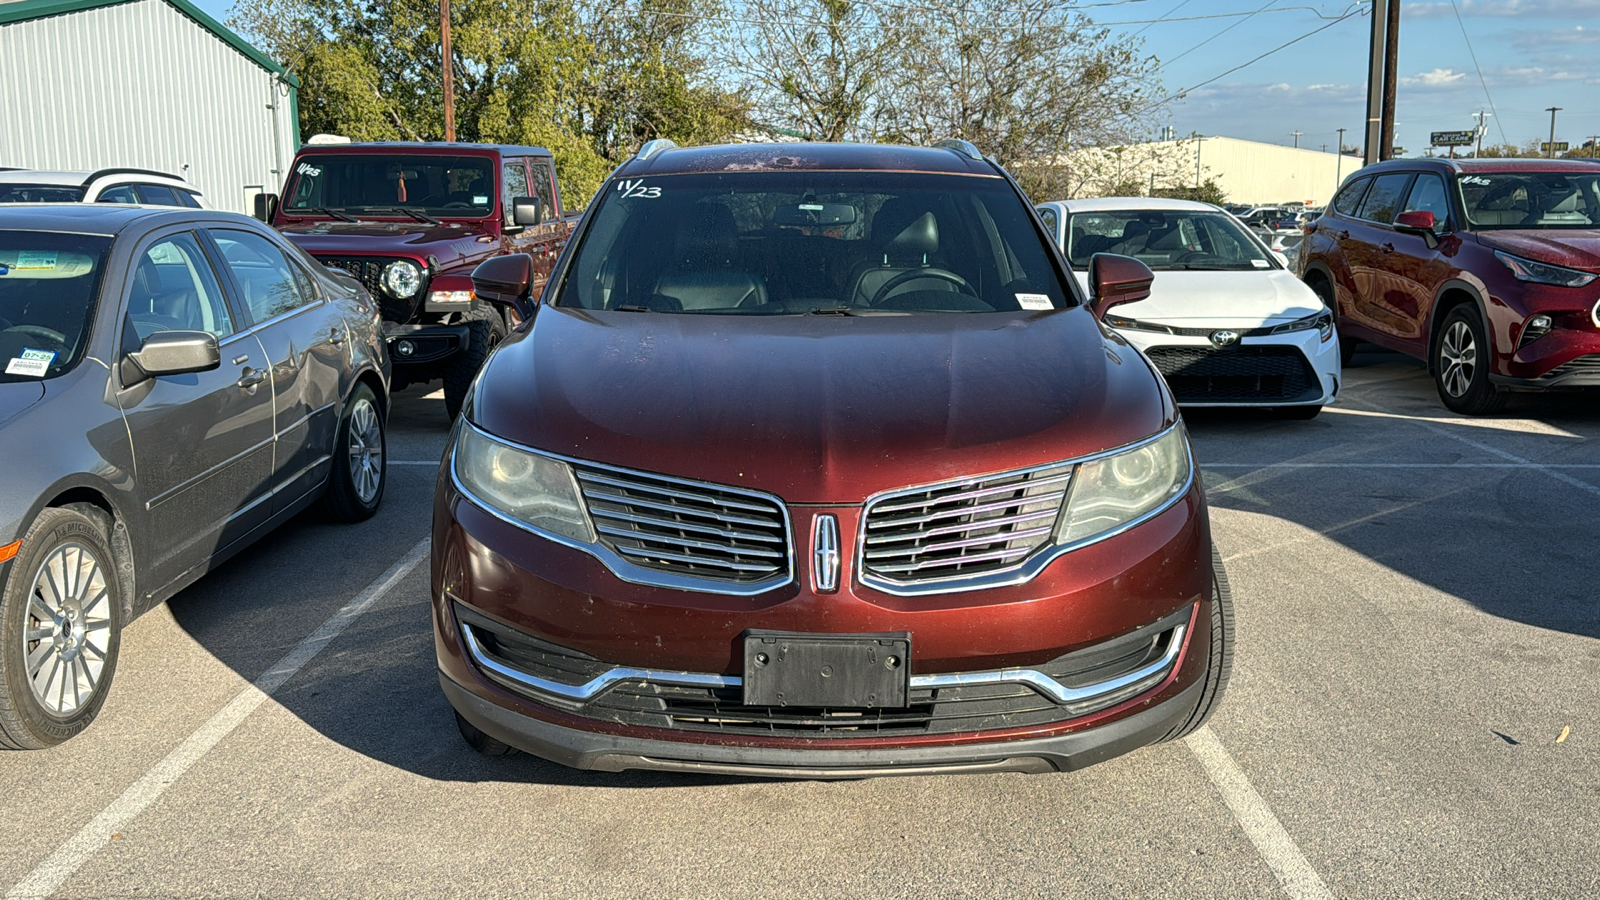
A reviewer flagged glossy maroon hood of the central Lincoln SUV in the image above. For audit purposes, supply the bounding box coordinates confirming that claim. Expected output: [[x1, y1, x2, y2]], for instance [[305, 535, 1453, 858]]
[[472, 301, 1176, 503]]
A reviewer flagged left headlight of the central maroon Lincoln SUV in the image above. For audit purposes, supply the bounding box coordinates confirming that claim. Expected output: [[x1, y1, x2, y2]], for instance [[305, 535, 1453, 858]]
[[454, 421, 595, 544]]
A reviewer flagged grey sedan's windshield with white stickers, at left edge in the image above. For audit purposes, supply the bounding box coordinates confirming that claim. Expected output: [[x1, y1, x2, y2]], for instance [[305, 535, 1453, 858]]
[[0, 231, 110, 383]]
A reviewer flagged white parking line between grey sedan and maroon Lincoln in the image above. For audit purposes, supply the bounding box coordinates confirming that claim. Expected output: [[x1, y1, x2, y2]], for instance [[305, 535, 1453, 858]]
[[5, 538, 429, 900]]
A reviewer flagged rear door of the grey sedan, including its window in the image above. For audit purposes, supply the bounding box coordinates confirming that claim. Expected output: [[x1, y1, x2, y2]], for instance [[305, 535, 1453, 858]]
[[208, 227, 347, 511]]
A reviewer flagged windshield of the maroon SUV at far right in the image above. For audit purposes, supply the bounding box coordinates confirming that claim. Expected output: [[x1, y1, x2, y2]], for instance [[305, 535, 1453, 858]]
[[1458, 171, 1600, 229]]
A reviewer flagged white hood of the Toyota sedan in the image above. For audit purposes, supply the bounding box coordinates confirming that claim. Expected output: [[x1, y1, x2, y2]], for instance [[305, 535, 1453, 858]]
[[1078, 269, 1323, 328]]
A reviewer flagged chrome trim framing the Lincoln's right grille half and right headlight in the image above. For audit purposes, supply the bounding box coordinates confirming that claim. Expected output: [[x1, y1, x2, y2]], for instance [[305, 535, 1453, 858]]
[[856, 422, 1195, 597]]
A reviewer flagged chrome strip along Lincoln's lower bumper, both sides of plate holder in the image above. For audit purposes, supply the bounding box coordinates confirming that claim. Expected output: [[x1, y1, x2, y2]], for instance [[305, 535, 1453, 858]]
[[458, 620, 1189, 705]]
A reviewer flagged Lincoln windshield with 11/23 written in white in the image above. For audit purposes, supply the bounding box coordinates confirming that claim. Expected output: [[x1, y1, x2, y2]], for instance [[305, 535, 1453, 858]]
[[558, 171, 1070, 315]]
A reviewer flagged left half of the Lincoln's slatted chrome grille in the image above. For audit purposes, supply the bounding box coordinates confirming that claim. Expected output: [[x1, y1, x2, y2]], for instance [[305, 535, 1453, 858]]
[[576, 464, 789, 585]]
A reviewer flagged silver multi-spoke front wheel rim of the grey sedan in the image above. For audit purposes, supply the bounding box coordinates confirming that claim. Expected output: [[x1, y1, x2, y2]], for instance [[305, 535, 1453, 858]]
[[22, 541, 114, 716]]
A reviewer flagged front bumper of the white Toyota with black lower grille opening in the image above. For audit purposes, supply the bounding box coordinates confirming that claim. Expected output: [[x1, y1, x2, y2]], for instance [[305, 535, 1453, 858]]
[[1117, 325, 1341, 407]]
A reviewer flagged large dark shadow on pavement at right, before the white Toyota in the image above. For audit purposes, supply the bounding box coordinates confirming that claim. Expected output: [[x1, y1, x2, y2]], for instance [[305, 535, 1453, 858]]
[[1184, 347, 1600, 637]]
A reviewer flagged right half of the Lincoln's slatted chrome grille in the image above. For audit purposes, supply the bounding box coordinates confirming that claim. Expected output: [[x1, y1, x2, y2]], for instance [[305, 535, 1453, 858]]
[[861, 463, 1072, 585]]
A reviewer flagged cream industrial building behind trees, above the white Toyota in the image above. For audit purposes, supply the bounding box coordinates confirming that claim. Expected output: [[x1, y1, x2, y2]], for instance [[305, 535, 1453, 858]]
[[1058, 138, 1362, 207]]
